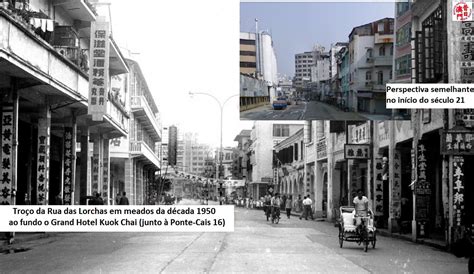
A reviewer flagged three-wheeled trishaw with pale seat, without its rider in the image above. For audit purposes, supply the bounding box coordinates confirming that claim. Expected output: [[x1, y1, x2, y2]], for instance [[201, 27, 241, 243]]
[[339, 206, 377, 252]]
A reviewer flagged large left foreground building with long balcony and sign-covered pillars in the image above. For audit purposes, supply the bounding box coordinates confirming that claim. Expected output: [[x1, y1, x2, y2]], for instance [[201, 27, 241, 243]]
[[0, 0, 130, 205]]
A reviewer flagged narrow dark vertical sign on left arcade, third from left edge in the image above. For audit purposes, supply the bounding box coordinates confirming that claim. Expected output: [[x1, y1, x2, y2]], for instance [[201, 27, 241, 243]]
[[63, 127, 74, 205]]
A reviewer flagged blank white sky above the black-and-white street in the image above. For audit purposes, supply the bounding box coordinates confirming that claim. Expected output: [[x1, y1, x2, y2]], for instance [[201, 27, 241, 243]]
[[109, 0, 253, 147]]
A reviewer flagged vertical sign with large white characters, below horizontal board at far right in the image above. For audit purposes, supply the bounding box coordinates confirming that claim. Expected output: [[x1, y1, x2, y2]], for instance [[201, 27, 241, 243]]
[[453, 156, 464, 226]]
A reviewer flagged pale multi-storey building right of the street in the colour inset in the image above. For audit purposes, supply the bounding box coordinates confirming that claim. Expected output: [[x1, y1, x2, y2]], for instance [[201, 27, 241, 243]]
[[349, 18, 394, 114]]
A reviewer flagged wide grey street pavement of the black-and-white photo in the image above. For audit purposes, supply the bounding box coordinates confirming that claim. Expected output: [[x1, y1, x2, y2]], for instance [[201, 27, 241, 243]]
[[0, 201, 467, 274]]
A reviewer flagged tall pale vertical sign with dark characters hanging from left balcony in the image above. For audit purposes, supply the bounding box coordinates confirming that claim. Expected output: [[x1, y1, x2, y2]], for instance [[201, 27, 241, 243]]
[[88, 21, 109, 121]]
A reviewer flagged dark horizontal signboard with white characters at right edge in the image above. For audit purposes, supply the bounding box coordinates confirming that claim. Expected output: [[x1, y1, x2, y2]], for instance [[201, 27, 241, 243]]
[[441, 130, 474, 155]]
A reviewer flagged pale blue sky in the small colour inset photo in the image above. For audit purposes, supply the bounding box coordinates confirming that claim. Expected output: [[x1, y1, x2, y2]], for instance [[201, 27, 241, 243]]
[[240, 2, 395, 76]]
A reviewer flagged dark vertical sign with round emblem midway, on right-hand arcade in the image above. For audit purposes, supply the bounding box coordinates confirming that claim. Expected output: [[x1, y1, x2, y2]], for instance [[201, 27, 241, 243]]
[[415, 142, 431, 221]]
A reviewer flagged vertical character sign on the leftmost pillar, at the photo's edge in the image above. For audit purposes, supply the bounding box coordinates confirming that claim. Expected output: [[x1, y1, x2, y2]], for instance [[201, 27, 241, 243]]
[[0, 104, 13, 205]]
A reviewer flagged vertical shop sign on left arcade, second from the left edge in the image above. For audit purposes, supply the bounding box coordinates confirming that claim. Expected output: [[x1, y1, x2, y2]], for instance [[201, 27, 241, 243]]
[[36, 119, 50, 205]]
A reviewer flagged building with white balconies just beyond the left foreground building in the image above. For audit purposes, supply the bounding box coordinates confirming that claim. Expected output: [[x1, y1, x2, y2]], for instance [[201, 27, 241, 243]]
[[111, 59, 162, 205]]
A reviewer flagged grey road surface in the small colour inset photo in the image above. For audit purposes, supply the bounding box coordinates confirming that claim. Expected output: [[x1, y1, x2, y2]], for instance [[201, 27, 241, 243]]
[[240, 101, 390, 120]]
